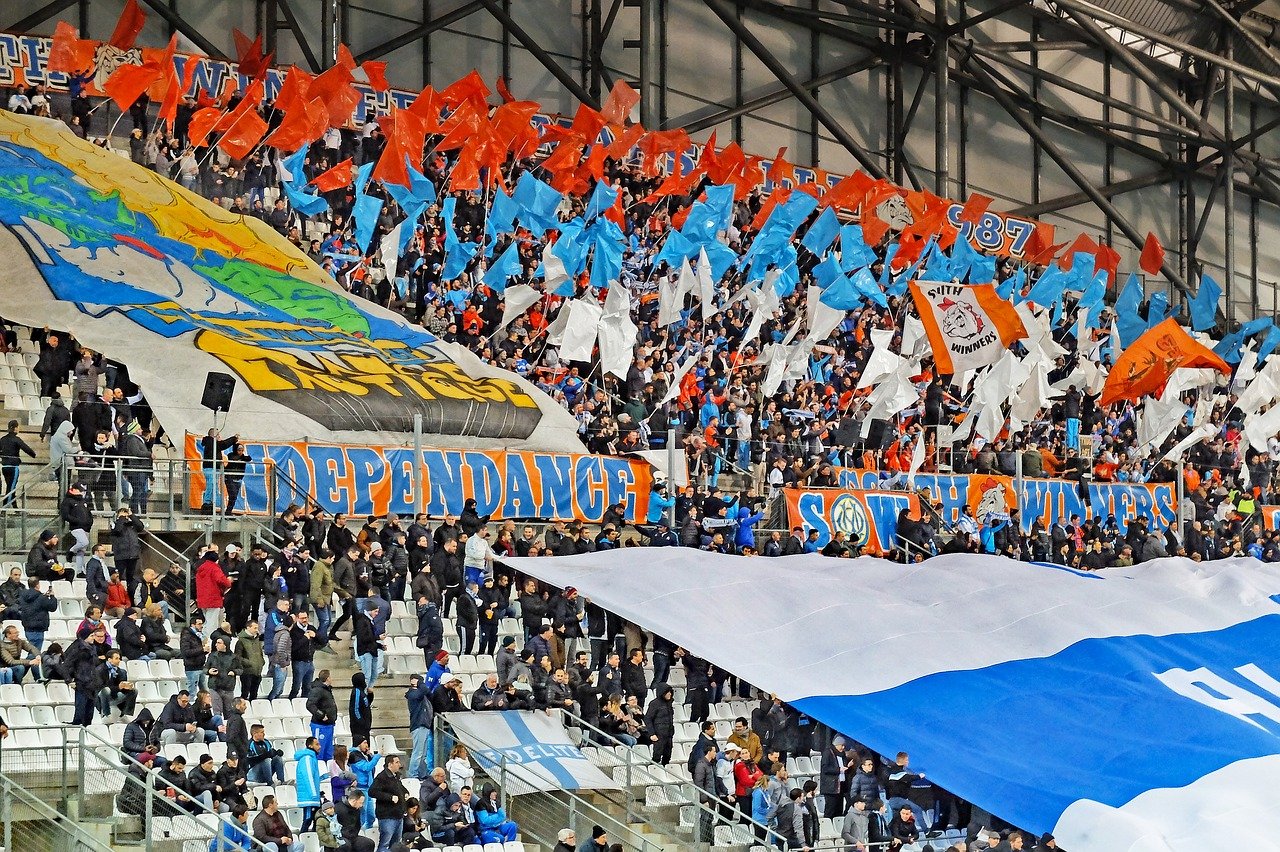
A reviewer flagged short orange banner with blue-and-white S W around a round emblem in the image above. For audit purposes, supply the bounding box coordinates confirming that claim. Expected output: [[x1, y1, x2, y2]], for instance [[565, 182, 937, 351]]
[[782, 489, 920, 551]]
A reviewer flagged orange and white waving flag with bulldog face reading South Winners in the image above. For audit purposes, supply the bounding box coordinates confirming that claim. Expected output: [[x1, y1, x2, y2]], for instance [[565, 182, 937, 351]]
[[910, 281, 1027, 376]]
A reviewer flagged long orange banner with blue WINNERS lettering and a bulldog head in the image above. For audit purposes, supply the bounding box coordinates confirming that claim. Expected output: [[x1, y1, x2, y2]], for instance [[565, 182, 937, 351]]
[[837, 467, 1178, 532]]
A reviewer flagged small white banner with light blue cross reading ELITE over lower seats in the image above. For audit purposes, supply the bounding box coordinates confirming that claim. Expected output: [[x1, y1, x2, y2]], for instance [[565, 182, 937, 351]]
[[448, 710, 618, 796]]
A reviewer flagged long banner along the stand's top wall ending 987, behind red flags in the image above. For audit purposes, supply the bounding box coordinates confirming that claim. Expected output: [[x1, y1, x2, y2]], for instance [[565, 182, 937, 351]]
[[0, 33, 1036, 257]]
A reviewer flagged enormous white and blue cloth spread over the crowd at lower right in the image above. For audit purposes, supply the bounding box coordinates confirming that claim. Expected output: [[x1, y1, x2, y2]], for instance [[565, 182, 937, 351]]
[[506, 548, 1280, 852]]
